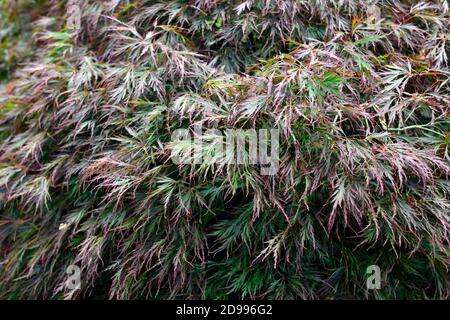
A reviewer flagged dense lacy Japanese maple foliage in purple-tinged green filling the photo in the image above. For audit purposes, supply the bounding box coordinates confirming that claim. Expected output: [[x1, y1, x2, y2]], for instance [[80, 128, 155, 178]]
[[0, 0, 450, 299]]
